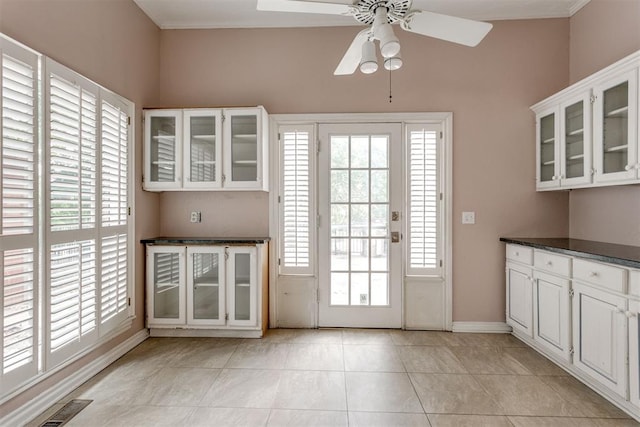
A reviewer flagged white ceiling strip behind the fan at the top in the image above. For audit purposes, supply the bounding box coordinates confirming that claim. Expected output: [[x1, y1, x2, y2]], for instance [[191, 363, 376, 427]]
[[134, 0, 590, 29]]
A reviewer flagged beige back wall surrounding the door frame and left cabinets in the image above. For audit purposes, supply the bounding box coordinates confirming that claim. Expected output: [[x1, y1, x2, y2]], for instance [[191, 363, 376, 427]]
[[160, 19, 569, 322]]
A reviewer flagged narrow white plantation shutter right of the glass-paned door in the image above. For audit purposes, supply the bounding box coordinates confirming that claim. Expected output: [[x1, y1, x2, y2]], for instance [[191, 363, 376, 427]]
[[407, 125, 440, 274]]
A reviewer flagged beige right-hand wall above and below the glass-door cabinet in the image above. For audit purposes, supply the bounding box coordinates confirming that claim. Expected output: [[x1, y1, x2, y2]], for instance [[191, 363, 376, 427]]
[[569, 0, 640, 245]]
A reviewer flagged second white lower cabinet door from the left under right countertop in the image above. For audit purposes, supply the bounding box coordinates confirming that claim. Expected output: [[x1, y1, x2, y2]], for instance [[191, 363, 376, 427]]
[[533, 271, 571, 361]]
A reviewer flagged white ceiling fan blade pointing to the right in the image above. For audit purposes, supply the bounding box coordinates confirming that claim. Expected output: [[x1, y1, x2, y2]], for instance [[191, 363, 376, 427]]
[[401, 10, 493, 47]]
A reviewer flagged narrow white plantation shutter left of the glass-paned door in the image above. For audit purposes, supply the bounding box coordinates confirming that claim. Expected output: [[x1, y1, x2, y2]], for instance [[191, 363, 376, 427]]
[[280, 125, 313, 274]]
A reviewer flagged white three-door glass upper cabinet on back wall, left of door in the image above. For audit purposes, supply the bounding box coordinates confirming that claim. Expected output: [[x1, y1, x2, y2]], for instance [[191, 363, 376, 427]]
[[143, 107, 269, 191]]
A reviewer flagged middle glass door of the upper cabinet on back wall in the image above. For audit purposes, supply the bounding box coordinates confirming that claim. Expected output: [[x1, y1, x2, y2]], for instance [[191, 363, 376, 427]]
[[183, 109, 222, 190]]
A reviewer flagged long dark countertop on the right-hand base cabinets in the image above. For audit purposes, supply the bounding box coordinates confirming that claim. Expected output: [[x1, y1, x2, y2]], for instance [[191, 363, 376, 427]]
[[500, 237, 640, 268]]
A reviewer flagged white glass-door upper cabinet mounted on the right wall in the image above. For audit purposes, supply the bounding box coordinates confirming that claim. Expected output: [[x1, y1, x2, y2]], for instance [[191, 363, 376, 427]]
[[531, 51, 640, 191]]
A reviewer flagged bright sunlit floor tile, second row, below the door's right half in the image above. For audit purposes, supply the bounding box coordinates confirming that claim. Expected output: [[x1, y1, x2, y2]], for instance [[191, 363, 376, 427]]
[[343, 345, 405, 372]]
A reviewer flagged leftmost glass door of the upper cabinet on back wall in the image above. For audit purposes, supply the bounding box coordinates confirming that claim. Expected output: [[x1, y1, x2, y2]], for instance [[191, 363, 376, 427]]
[[144, 110, 182, 191]]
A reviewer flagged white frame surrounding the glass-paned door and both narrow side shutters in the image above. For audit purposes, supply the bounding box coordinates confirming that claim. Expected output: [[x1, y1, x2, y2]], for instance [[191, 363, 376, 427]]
[[269, 112, 453, 331]]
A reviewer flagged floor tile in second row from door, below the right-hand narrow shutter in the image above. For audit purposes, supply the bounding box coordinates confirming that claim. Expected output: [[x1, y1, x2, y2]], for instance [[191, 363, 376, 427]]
[[397, 346, 467, 374]]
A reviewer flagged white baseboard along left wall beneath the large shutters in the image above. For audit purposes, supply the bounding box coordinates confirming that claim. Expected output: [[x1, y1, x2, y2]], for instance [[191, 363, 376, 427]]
[[0, 329, 149, 426]]
